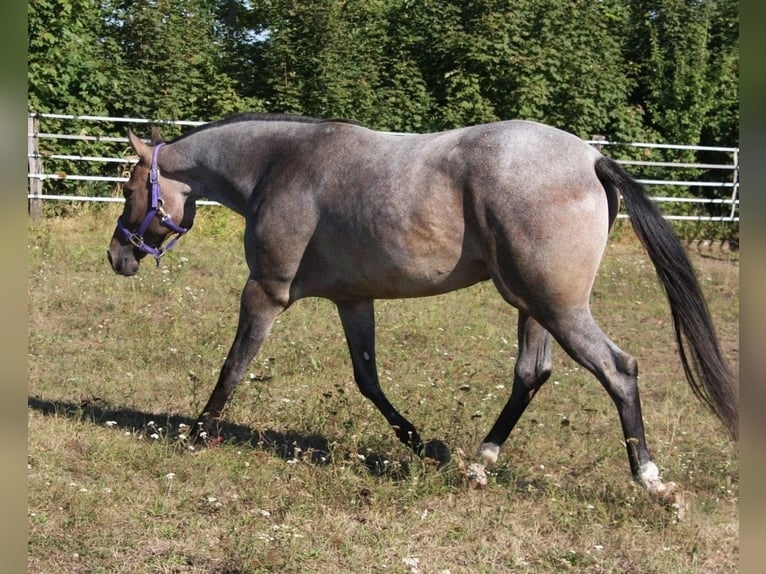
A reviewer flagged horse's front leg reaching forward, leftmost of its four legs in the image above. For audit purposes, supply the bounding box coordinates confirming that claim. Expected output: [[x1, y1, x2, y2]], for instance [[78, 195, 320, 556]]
[[194, 278, 287, 438]]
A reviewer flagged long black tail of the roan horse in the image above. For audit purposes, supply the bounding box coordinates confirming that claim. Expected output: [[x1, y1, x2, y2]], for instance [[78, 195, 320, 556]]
[[595, 157, 739, 440]]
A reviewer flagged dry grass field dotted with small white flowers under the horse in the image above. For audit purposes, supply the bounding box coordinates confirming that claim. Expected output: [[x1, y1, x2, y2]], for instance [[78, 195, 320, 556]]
[[28, 207, 739, 574]]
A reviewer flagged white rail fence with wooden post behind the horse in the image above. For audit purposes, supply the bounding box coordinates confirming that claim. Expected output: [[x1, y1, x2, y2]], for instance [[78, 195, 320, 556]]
[[27, 112, 739, 224]]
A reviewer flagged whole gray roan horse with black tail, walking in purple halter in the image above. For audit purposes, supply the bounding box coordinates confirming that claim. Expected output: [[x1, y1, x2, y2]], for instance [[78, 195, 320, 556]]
[[108, 114, 738, 504]]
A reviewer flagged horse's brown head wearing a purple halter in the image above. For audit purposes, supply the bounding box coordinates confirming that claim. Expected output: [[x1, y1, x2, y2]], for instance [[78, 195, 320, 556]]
[[107, 130, 195, 276]]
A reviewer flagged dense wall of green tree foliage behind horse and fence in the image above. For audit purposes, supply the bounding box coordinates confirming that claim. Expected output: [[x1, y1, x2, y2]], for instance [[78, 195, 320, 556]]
[[29, 0, 739, 241]]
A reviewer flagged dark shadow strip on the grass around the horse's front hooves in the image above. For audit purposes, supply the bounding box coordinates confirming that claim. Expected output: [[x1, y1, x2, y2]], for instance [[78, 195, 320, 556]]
[[27, 397, 410, 480]]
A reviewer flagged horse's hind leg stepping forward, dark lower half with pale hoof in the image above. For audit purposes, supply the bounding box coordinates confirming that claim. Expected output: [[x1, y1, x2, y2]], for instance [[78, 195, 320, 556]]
[[479, 311, 553, 463]]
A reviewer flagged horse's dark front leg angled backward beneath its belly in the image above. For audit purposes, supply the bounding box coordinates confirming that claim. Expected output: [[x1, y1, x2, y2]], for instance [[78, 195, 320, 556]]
[[336, 300, 449, 462]]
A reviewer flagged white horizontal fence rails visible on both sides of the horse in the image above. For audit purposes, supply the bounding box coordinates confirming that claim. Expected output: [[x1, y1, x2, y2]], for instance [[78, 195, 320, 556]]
[[27, 112, 739, 223]]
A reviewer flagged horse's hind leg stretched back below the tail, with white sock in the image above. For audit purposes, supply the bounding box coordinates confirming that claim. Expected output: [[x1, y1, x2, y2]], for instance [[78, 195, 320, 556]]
[[550, 309, 676, 502]]
